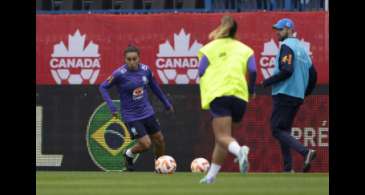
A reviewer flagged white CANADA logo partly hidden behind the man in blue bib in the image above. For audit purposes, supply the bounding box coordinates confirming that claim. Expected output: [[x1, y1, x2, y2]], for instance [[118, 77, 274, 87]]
[[260, 39, 312, 79]]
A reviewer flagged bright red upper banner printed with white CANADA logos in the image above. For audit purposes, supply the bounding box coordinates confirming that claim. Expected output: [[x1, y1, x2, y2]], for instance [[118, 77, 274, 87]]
[[36, 12, 329, 85]]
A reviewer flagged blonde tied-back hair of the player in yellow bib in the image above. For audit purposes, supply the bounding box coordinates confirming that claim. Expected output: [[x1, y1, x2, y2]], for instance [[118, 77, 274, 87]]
[[209, 15, 237, 40]]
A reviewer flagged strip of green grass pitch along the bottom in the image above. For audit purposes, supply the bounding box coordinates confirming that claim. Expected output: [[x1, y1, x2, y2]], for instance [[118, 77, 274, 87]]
[[36, 171, 329, 195]]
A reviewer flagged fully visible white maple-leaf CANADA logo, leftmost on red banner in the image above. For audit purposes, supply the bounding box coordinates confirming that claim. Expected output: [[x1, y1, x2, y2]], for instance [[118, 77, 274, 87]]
[[49, 30, 100, 85]]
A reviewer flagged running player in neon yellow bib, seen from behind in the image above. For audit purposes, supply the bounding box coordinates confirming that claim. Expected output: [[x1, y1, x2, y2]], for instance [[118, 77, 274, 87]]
[[198, 16, 256, 184]]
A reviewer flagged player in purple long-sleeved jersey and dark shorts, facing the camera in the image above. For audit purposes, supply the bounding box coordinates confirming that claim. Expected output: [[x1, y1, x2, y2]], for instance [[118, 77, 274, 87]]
[[99, 46, 174, 171]]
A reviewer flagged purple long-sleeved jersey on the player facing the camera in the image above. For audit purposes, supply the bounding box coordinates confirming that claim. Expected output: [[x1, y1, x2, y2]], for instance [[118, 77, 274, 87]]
[[99, 64, 171, 122]]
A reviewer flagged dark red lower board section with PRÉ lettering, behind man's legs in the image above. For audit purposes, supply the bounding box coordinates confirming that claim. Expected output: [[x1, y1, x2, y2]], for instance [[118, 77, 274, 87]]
[[222, 95, 329, 172]]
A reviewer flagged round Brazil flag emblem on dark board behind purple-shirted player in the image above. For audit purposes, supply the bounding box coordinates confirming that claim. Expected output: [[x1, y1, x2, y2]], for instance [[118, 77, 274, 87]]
[[86, 100, 139, 171]]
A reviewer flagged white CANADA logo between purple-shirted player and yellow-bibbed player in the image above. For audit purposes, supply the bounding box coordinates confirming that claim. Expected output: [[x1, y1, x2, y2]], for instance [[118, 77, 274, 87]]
[[156, 29, 203, 84]]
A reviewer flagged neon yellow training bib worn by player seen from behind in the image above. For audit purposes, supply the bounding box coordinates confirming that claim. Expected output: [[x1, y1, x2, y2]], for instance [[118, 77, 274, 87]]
[[198, 38, 254, 110]]
